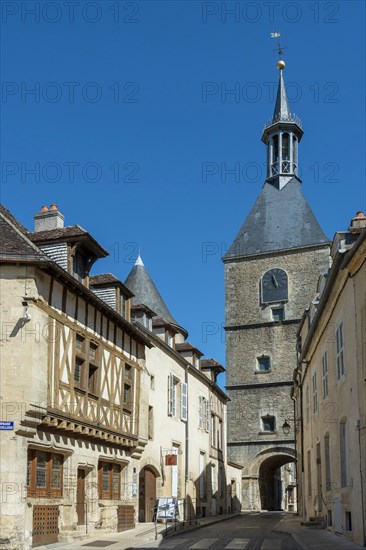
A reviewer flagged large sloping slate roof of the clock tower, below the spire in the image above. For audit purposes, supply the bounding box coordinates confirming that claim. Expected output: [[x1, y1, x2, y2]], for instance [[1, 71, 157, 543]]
[[223, 178, 329, 261]]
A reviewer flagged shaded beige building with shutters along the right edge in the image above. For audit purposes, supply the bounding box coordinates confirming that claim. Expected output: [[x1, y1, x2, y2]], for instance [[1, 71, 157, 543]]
[[294, 217, 366, 546]]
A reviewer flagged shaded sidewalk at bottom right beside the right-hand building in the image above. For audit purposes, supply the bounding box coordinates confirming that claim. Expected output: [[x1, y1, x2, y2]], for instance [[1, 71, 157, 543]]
[[274, 515, 362, 550]]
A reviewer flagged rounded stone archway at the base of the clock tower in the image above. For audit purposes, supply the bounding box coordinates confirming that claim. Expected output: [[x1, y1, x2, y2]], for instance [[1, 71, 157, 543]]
[[243, 447, 296, 511]]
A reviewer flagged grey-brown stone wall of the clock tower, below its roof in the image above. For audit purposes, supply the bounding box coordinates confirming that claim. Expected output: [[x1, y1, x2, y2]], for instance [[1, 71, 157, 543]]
[[225, 245, 329, 509]]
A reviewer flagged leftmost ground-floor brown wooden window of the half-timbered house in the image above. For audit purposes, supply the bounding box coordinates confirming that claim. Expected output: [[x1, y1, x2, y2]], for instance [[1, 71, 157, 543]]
[[27, 449, 64, 498]]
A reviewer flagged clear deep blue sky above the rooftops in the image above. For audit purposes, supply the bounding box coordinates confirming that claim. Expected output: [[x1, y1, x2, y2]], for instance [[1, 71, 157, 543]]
[[1, 0, 366, 385]]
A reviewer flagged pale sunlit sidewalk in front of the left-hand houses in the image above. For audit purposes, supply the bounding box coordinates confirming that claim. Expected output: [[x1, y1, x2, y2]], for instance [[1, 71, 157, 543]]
[[37, 513, 240, 550]]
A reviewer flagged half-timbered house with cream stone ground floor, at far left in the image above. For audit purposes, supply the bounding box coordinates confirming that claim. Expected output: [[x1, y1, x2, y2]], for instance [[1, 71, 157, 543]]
[[0, 206, 152, 549]]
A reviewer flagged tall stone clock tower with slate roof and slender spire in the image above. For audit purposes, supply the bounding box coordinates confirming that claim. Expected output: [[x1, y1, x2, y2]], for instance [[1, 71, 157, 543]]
[[223, 60, 330, 510]]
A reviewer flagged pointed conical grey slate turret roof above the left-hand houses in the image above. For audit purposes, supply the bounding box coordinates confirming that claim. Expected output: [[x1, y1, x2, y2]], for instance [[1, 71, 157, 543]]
[[125, 257, 187, 335]]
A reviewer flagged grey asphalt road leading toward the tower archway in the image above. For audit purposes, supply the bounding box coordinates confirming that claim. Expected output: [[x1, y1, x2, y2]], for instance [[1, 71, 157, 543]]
[[129, 512, 302, 550]]
